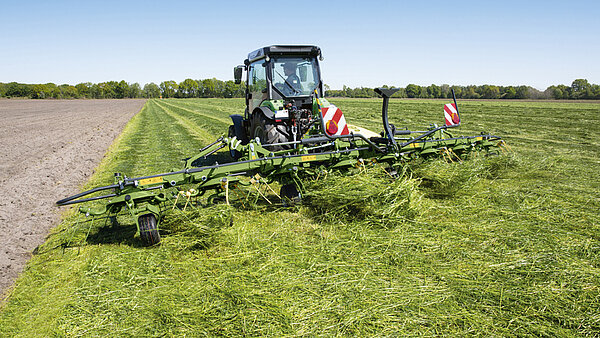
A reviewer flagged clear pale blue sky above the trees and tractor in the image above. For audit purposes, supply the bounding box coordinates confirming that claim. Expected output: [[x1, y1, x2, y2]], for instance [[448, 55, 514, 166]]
[[0, 0, 600, 89]]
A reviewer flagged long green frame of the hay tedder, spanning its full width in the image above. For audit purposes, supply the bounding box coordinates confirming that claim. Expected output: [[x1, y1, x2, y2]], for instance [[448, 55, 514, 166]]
[[57, 129, 501, 218]]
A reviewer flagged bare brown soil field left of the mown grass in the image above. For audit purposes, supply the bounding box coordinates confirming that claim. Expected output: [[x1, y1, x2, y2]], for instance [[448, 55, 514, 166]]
[[0, 100, 145, 298]]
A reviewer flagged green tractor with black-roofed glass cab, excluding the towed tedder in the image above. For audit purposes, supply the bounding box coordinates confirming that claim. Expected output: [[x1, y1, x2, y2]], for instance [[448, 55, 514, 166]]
[[230, 45, 323, 149]]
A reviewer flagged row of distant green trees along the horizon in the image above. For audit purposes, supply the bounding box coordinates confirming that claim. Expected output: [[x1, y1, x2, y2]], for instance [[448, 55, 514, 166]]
[[0, 78, 600, 100]]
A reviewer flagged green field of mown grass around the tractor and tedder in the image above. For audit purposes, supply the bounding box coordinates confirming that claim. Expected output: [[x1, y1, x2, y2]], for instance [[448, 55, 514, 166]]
[[0, 99, 600, 337]]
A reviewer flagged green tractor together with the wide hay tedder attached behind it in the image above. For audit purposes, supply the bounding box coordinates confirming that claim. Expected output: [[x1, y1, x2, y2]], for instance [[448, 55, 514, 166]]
[[57, 46, 504, 245]]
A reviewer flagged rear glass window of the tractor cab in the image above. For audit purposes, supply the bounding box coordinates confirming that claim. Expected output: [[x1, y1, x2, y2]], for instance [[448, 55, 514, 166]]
[[272, 58, 319, 97]]
